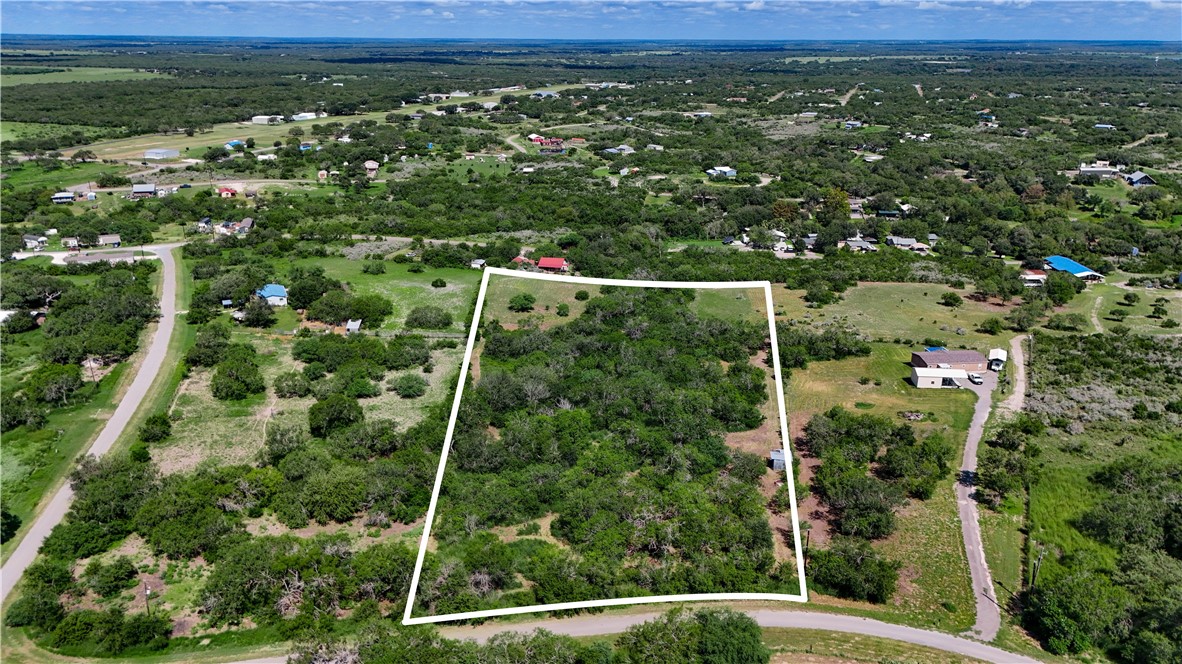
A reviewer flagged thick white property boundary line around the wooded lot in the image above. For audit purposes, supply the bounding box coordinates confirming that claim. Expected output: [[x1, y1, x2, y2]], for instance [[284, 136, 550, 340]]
[[402, 267, 808, 625]]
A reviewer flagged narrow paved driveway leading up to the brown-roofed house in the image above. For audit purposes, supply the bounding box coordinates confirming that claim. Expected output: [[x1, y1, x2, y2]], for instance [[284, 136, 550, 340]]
[[956, 371, 1001, 642]]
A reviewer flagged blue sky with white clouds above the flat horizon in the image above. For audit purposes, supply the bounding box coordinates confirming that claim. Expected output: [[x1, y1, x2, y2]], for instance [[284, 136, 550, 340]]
[[0, 0, 1182, 41]]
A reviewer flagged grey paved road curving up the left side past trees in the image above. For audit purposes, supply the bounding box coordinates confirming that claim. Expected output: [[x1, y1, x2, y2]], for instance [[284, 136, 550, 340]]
[[0, 245, 178, 601]]
